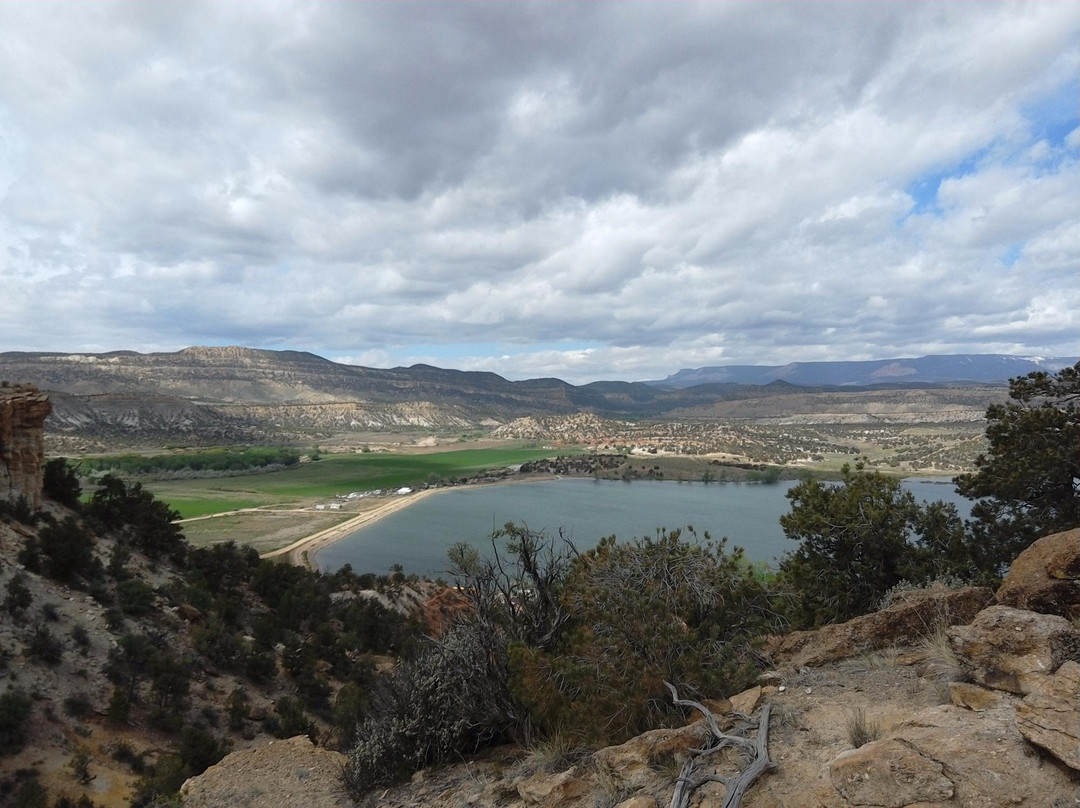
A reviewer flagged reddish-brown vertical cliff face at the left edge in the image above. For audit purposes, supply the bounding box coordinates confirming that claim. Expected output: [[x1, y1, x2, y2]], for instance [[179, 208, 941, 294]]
[[0, 385, 52, 509]]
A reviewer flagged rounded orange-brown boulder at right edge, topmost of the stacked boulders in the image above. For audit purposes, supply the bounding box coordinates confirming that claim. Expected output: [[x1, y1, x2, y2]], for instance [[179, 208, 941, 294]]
[[995, 528, 1080, 617]]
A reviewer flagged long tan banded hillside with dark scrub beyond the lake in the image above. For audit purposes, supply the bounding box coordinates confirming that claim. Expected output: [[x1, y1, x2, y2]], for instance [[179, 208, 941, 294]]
[[0, 348, 1004, 452]]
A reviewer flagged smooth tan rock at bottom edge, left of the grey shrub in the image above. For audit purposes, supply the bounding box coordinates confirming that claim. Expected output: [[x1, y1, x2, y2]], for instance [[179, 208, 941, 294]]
[[180, 736, 352, 808]]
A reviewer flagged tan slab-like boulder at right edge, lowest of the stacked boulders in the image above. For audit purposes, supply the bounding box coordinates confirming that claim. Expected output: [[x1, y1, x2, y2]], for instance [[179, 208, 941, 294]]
[[1016, 662, 1080, 771]]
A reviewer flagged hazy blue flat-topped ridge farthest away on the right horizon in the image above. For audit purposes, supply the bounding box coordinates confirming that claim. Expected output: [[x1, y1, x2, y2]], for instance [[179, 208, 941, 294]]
[[646, 353, 1077, 390]]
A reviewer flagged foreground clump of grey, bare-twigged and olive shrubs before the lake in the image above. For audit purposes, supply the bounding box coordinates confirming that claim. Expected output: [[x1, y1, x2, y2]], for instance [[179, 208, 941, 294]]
[[346, 525, 777, 796]]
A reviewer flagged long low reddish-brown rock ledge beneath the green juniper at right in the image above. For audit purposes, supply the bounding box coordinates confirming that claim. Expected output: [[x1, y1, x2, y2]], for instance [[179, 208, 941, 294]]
[[765, 587, 994, 668]]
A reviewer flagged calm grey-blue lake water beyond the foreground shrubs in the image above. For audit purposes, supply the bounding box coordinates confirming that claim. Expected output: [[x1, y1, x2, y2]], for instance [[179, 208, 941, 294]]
[[315, 477, 969, 578]]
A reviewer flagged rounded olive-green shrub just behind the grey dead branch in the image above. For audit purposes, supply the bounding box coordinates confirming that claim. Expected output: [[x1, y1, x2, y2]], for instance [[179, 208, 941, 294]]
[[511, 528, 780, 743]]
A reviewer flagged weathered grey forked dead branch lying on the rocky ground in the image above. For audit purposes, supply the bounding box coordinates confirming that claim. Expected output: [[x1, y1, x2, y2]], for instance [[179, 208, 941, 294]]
[[664, 682, 773, 808]]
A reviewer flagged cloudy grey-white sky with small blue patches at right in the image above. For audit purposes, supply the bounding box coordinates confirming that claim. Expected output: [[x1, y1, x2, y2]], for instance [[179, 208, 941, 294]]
[[0, 0, 1080, 382]]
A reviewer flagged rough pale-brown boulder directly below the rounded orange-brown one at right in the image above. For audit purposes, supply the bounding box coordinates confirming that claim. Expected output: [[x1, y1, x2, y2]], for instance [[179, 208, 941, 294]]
[[946, 606, 1080, 693]]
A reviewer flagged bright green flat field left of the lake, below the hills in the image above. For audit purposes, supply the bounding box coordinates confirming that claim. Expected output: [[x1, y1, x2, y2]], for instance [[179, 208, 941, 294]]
[[146, 448, 568, 519]]
